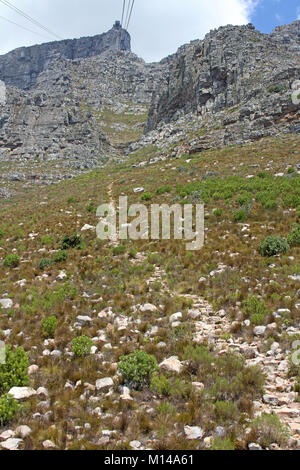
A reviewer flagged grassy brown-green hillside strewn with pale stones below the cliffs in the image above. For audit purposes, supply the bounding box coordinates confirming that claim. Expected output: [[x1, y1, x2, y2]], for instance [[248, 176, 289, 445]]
[[0, 134, 300, 449]]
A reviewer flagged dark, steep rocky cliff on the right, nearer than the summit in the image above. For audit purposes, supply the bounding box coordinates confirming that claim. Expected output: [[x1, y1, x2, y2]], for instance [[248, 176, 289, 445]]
[[146, 22, 300, 150]]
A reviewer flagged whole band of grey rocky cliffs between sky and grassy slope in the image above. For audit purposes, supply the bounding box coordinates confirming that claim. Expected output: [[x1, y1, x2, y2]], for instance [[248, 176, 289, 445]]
[[0, 21, 300, 175]]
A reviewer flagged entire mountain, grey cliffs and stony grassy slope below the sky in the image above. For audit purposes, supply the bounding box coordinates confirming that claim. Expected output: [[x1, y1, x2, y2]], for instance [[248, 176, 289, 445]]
[[0, 21, 300, 452]]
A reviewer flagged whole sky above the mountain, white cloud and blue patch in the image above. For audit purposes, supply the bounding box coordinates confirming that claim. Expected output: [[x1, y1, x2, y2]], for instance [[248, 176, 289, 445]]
[[0, 0, 300, 62]]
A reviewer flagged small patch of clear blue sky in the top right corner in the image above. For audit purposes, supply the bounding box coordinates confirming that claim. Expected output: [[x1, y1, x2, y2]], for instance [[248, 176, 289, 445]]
[[251, 0, 300, 33]]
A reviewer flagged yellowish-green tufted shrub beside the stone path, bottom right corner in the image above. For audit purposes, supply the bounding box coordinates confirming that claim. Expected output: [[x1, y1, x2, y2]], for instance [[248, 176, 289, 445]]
[[251, 413, 289, 447]]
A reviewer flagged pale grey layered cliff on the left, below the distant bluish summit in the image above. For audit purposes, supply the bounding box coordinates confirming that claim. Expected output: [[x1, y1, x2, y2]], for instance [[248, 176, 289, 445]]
[[0, 50, 166, 169]]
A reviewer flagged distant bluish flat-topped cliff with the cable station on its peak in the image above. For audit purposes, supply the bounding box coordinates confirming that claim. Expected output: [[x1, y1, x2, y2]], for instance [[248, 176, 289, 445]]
[[0, 23, 131, 90]]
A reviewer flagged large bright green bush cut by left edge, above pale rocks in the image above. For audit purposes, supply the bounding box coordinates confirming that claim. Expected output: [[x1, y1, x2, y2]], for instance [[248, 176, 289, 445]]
[[0, 346, 29, 395]]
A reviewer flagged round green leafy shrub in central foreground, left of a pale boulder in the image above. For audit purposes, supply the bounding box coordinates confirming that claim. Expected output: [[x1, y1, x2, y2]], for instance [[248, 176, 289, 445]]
[[118, 350, 158, 388]]
